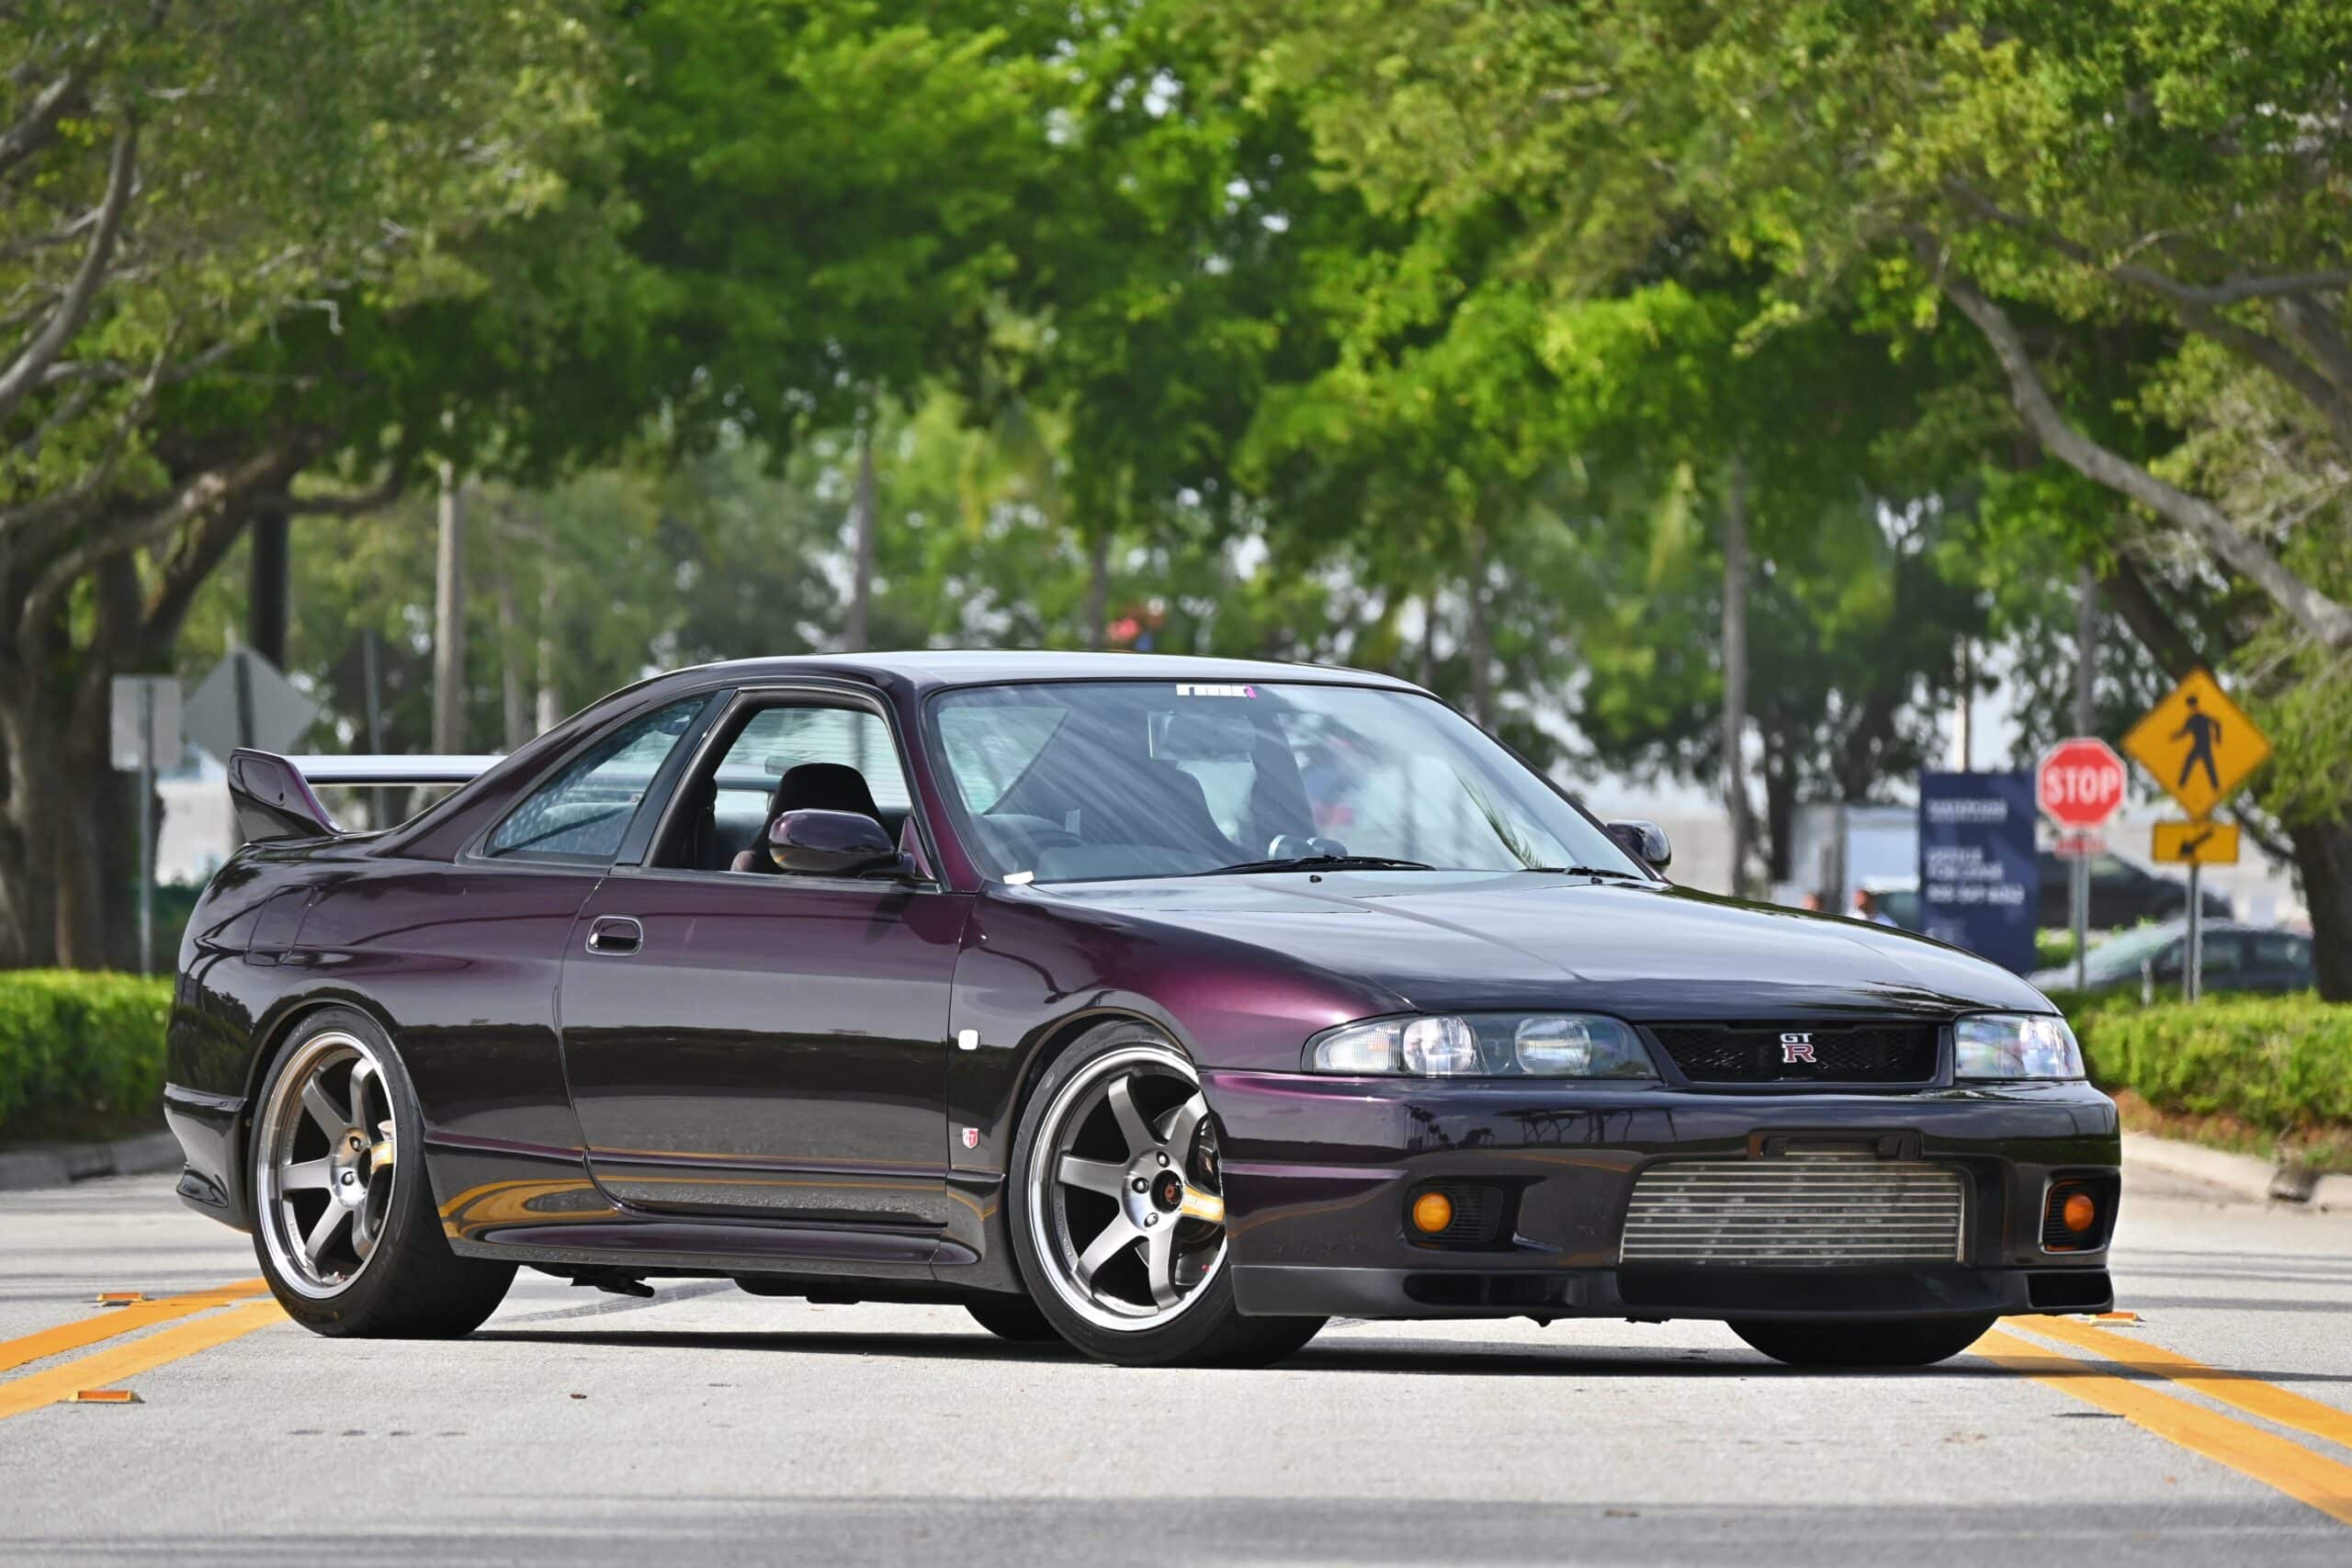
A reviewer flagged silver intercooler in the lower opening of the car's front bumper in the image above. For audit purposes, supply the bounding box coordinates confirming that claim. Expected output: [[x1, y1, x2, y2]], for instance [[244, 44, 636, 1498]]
[[1618, 1155, 1966, 1267]]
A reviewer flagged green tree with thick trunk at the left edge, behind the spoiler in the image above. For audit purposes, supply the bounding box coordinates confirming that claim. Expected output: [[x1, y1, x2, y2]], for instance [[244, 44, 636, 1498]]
[[0, 0, 616, 964]]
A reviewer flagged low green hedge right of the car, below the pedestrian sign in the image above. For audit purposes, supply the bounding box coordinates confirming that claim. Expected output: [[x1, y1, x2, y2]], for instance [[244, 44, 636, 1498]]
[[2070, 995, 2352, 1138]]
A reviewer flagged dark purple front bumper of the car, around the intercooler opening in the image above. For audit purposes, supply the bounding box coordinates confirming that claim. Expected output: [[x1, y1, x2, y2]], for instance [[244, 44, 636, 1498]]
[[1204, 1072, 2121, 1319]]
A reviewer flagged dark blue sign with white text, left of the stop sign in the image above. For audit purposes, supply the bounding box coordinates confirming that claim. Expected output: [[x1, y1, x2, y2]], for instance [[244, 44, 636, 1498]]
[[1919, 773, 2041, 976]]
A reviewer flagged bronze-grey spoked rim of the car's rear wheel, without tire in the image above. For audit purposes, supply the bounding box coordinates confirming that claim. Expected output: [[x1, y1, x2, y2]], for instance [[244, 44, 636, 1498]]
[[254, 1032, 400, 1298]]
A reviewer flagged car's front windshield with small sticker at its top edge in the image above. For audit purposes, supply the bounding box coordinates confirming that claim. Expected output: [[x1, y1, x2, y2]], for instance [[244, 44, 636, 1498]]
[[932, 682, 1646, 882]]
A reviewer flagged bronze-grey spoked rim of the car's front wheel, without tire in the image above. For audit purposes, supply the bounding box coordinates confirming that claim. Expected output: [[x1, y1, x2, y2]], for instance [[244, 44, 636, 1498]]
[[1025, 1042, 1226, 1331]]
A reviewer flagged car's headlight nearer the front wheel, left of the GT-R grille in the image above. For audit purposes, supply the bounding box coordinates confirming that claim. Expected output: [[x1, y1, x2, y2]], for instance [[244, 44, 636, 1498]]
[[1307, 1013, 1658, 1079]]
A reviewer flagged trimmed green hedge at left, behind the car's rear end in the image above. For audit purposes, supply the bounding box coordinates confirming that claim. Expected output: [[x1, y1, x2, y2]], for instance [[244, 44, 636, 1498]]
[[0, 968, 172, 1138]]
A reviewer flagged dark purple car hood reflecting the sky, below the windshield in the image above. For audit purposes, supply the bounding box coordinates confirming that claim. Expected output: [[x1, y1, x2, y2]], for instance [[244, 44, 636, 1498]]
[[1035, 872, 2049, 1021]]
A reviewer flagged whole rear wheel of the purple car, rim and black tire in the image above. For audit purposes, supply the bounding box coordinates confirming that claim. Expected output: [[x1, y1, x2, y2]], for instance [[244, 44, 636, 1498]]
[[252, 1009, 515, 1337]]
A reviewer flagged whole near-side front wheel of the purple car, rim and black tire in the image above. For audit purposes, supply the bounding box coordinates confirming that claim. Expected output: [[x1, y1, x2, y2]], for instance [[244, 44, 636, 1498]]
[[1012, 1022, 1324, 1366]]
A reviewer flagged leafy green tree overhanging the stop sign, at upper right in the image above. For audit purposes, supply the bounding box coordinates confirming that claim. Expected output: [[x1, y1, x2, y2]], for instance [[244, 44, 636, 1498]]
[[1218, 0, 2352, 997]]
